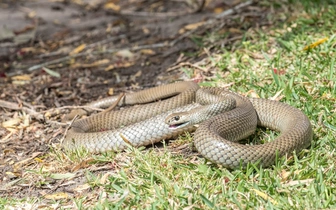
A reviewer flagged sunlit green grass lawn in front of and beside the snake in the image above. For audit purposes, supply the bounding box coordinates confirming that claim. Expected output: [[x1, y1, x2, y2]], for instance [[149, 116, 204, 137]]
[[0, 1, 336, 209]]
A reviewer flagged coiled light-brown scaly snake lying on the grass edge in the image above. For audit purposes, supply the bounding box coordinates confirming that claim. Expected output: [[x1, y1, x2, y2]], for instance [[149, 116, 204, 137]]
[[62, 81, 313, 169]]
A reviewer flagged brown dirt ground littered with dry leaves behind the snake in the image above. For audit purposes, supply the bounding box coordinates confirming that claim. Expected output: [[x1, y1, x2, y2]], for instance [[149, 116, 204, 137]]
[[0, 0, 273, 198]]
